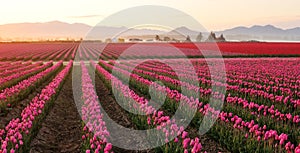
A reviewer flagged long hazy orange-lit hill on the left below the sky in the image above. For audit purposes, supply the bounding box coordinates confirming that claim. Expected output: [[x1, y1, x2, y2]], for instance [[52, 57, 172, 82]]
[[0, 21, 163, 40]]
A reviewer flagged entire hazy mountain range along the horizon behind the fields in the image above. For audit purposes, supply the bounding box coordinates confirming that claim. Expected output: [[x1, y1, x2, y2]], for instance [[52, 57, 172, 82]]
[[0, 21, 300, 41]]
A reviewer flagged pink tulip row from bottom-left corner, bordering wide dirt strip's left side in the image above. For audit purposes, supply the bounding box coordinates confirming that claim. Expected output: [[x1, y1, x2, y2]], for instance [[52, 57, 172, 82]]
[[0, 61, 73, 153]]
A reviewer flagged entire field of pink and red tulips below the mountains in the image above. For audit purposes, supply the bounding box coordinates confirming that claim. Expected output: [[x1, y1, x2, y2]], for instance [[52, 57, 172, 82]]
[[0, 42, 300, 153]]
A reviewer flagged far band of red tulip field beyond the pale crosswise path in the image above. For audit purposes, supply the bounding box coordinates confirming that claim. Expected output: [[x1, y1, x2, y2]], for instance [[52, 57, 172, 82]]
[[0, 42, 300, 61]]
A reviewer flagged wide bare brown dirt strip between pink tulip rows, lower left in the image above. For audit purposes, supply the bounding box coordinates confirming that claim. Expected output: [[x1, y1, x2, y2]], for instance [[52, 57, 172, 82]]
[[30, 75, 82, 153]]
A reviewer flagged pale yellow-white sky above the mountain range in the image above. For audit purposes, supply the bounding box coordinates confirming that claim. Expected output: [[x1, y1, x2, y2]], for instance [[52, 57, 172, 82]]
[[0, 0, 300, 30]]
